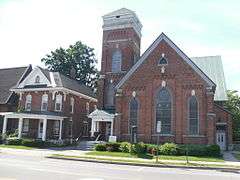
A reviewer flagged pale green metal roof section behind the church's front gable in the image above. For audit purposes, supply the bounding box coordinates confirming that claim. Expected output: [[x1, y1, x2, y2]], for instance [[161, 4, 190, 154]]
[[191, 56, 227, 101]]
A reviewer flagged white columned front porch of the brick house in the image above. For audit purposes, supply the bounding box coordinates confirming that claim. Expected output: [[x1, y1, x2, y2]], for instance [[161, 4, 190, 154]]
[[0, 112, 66, 141]]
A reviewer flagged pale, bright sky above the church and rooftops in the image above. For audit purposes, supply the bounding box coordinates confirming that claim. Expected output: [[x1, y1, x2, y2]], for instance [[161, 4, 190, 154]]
[[0, 0, 240, 91]]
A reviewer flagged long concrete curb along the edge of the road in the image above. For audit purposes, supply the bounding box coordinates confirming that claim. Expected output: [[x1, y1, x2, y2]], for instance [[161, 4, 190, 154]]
[[46, 156, 240, 174]]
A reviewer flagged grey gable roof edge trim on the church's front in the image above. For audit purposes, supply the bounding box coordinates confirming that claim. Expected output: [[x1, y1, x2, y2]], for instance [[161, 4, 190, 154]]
[[115, 33, 216, 89]]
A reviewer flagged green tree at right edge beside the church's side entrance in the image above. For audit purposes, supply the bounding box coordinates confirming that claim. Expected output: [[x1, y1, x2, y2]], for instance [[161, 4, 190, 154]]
[[225, 91, 240, 141]]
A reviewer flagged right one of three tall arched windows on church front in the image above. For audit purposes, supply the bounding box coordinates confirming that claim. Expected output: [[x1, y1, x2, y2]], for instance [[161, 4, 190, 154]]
[[188, 96, 199, 135]]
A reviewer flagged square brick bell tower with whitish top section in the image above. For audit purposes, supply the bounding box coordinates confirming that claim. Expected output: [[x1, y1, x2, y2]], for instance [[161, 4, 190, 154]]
[[98, 8, 142, 109]]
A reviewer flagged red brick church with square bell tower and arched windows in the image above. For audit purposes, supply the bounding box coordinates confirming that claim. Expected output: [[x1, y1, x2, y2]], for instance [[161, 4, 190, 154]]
[[89, 8, 232, 149]]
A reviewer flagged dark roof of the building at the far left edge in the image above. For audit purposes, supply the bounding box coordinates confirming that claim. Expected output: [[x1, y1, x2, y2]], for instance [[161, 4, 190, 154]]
[[0, 65, 32, 104]]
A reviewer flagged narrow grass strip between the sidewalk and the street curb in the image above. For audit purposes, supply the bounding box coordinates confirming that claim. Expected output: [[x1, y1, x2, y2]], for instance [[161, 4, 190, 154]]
[[49, 154, 240, 169]]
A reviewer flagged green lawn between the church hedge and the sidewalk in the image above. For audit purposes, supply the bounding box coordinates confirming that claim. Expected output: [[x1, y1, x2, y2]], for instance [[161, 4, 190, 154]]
[[86, 151, 224, 162]]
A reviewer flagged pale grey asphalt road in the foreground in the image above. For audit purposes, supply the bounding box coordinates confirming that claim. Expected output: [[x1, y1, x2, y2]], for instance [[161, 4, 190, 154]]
[[0, 153, 240, 180]]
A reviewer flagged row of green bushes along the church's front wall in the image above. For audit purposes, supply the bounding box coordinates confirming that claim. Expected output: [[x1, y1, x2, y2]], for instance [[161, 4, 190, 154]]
[[95, 142, 221, 157]]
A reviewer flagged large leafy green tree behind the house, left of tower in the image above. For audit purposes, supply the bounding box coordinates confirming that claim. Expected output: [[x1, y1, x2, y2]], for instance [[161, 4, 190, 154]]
[[41, 41, 99, 89]]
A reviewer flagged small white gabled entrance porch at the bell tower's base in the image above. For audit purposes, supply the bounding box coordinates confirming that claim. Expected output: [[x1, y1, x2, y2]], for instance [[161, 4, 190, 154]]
[[88, 109, 115, 137]]
